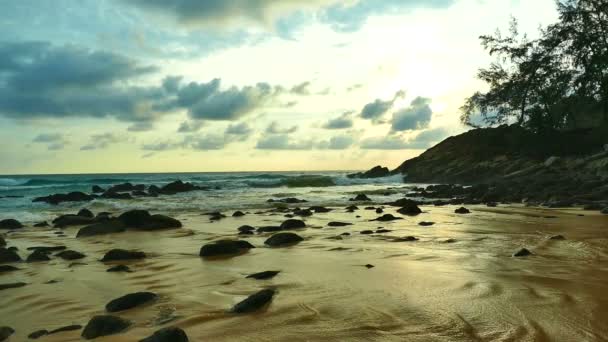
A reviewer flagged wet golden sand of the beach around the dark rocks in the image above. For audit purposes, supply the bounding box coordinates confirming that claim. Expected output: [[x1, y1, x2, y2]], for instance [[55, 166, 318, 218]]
[[0, 206, 608, 341]]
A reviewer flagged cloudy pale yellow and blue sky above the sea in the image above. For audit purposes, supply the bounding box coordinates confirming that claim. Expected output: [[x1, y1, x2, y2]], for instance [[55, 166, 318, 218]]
[[0, 0, 557, 174]]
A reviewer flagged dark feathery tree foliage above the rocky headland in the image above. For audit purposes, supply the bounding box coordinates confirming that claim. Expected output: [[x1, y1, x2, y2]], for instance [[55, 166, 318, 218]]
[[461, 0, 608, 131]]
